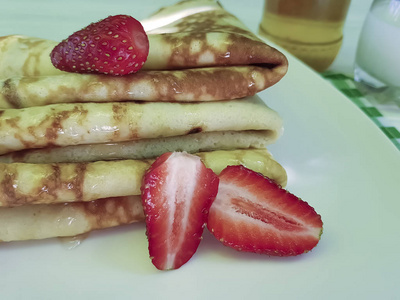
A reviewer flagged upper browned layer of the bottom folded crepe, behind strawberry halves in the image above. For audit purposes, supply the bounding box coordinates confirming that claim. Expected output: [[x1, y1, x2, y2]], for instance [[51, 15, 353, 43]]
[[0, 150, 286, 207]]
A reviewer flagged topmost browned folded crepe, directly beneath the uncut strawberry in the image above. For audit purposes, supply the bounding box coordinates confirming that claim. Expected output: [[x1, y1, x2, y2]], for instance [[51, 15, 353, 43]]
[[0, 0, 288, 109]]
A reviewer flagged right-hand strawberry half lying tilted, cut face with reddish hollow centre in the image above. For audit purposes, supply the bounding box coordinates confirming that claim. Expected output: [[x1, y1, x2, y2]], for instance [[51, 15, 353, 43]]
[[207, 166, 322, 256]]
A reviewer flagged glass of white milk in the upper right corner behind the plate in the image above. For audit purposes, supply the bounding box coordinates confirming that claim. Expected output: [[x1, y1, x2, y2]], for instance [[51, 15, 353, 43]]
[[355, 0, 400, 88]]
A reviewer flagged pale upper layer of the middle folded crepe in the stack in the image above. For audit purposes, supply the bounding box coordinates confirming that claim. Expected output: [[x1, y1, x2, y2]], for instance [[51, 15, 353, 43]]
[[0, 96, 282, 154]]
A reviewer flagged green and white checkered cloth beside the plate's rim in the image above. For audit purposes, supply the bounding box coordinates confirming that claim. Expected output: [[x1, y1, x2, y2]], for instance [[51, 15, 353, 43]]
[[321, 72, 400, 150]]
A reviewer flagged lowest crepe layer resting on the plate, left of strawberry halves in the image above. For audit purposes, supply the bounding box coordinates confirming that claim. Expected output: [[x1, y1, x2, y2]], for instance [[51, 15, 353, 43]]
[[0, 196, 144, 242]]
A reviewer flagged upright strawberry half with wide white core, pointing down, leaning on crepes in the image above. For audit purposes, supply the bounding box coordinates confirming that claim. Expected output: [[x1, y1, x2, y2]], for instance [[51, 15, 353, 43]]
[[142, 152, 219, 270]]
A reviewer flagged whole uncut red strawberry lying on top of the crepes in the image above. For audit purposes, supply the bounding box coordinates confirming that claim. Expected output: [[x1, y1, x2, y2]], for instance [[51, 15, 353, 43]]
[[50, 15, 149, 75]]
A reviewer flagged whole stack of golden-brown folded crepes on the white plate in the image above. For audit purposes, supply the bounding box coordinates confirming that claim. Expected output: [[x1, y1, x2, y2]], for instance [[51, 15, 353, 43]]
[[0, 0, 287, 241]]
